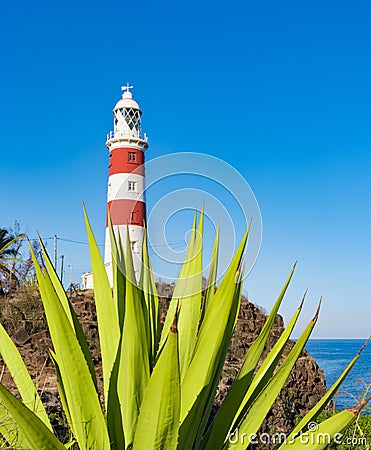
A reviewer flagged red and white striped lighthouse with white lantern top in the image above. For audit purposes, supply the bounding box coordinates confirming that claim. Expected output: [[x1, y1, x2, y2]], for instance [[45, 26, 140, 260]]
[[104, 83, 148, 281]]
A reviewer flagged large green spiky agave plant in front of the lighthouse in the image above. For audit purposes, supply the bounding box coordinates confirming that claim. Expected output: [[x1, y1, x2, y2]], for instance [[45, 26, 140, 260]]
[[0, 209, 370, 450]]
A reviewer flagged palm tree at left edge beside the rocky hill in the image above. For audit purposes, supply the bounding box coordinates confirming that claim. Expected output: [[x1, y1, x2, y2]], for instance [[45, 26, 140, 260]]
[[0, 228, 25, 290]]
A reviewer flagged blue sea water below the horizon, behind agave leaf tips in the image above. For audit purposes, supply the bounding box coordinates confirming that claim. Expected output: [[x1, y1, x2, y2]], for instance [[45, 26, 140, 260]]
[[306, 339, 371, 409]]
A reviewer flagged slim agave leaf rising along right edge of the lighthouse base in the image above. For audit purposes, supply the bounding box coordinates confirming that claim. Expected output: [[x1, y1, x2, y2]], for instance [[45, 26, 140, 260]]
[[140, 228, 160, 368]]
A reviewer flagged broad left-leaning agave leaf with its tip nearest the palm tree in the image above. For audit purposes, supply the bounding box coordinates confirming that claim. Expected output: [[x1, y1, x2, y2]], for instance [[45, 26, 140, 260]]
[[32, 246, 109, 449]]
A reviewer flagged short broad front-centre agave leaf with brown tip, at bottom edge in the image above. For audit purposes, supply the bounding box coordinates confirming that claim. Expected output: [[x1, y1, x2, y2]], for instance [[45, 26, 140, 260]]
[[133, 316, 180, 450]]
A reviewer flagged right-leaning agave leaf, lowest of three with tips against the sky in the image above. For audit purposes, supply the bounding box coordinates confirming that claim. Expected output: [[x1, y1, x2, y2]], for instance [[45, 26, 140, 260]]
[[223, 300, 320, 450]]
